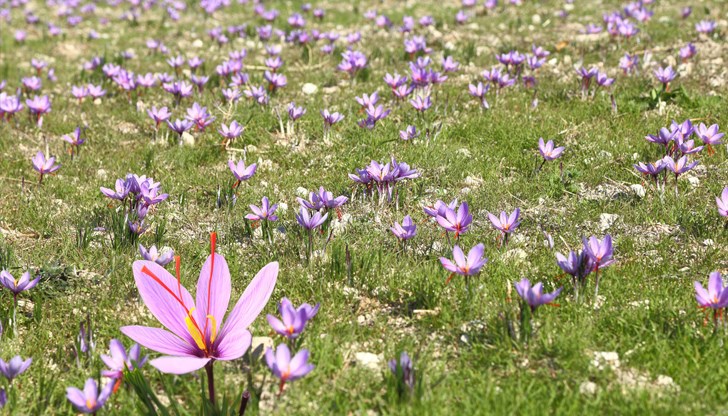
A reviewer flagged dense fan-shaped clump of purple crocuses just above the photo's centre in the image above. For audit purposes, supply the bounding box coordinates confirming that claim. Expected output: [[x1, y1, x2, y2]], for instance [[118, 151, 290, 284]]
[[349, 157, 420, 204]]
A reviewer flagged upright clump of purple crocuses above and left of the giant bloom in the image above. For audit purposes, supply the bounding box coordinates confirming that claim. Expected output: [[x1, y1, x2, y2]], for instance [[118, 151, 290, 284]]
[[101, 173, 169, 235]]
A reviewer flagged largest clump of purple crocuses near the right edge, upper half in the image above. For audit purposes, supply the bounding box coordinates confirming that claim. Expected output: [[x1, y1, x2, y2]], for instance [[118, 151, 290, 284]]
[[634, 119, 724, 195]]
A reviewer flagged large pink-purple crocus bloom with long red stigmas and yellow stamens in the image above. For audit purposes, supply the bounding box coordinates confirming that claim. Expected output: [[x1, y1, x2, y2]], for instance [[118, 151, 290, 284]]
[[121, 233, 278, 374]]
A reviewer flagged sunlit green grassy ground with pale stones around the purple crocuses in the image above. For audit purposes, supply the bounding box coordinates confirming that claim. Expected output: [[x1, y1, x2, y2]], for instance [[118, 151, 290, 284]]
[[0, 0, 728, 415]]
